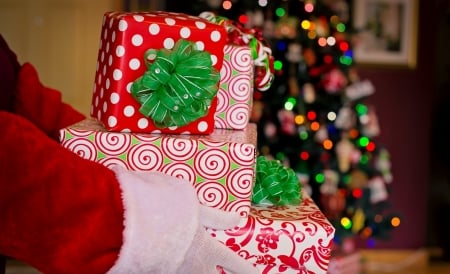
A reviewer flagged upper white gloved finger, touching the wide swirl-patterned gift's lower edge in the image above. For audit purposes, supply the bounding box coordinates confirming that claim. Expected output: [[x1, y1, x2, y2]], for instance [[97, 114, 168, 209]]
[[200, 205, 241, 230]]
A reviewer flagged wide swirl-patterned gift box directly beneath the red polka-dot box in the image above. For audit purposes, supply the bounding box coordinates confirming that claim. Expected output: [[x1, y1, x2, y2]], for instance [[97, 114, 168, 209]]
[[60, 118, 256, 217]]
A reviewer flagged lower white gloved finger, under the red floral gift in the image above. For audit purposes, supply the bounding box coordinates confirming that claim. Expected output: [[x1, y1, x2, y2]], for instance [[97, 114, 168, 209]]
[[199, 231, 259, 274]]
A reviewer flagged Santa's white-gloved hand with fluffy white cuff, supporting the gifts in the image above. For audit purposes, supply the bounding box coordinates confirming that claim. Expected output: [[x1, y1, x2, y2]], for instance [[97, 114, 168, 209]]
[[110, 167, 258, 274]]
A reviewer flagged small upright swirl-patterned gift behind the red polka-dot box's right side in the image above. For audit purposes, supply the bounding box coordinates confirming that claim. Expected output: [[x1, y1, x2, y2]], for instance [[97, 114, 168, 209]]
[[214, 44, 254, 129]]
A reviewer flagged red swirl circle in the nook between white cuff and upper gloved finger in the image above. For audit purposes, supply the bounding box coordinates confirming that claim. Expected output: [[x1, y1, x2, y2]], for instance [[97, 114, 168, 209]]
[[195, 181, 228, 208]]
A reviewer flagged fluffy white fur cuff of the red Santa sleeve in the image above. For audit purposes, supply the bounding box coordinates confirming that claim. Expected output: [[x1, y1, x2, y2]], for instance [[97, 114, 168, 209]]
[[108, 167, 199, 274]]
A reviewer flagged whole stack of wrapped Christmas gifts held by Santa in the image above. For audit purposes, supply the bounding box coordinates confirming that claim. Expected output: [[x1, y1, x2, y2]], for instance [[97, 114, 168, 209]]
[[60, 12, 334, 273]]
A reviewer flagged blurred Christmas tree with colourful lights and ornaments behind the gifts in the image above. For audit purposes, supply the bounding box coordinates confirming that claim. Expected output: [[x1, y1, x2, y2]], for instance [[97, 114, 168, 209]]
[[178, 0, 400, 246]]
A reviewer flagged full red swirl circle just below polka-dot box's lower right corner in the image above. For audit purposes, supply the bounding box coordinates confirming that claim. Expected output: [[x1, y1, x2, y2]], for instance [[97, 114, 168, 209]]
[[194, 148, 230, 180]]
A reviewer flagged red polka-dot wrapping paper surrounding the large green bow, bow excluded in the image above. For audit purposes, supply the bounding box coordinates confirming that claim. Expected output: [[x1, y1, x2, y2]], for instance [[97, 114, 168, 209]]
[[91, 11, 227, 134]]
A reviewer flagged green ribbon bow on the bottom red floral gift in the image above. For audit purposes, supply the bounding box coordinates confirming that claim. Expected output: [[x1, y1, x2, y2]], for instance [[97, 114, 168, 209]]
[[252, 156, 302, 206]]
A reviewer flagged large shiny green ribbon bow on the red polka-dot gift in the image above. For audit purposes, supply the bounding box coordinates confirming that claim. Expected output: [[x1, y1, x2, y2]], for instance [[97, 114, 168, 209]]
[[131, 39, 220, 128]]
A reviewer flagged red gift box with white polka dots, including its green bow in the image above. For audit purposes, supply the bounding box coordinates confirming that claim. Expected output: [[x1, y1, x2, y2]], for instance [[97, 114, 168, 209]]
[[91, 11, 226, 134]]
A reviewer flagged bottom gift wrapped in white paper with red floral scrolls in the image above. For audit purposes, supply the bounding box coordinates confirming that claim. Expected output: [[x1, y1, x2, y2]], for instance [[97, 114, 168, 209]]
[[207, 191, 335, 274]]
